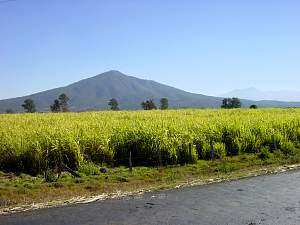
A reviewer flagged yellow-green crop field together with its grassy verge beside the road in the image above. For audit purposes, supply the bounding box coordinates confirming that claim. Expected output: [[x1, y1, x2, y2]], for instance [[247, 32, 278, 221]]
[[0, 109, 300, 207]]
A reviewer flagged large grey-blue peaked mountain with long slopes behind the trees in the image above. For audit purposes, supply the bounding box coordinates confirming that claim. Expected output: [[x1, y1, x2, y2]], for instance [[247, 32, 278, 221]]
[[0, 70, 300, 113]]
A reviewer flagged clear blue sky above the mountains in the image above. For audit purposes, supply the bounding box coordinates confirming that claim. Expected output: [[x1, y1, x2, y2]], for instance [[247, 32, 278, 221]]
[[0, 0, 300, 99]]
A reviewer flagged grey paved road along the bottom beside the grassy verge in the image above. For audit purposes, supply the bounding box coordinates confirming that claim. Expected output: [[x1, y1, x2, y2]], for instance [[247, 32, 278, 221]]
[[0, 171, 300, 225]]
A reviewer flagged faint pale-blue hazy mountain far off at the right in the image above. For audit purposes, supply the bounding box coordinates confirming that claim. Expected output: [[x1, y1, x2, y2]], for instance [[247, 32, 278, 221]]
[[221, 88, 300, 102]]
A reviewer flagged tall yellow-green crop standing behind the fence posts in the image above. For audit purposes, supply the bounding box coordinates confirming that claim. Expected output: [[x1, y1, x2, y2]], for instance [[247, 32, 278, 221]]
[[0, 109, 300, 175]]
